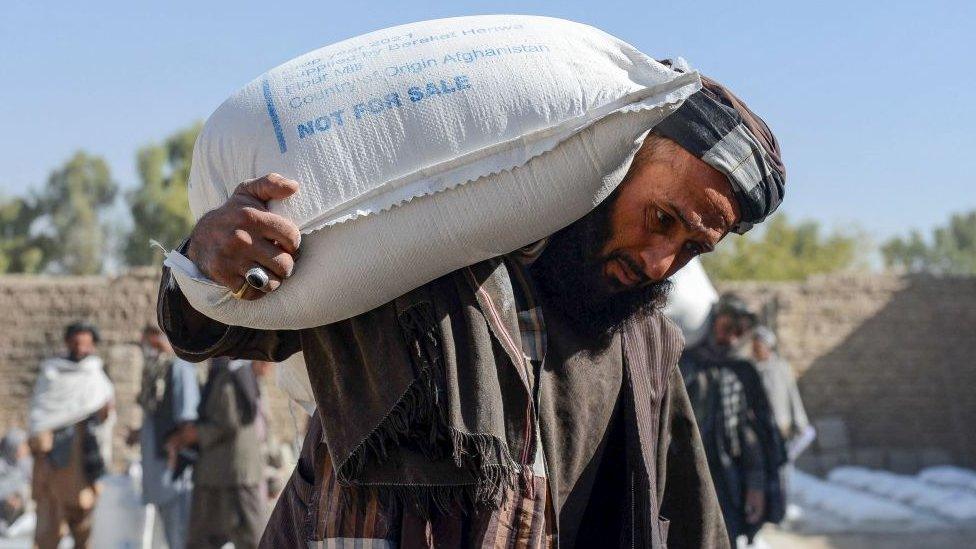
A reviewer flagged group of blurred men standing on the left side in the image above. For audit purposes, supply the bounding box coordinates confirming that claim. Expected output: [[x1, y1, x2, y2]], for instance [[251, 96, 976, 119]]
[[0, 322, 289, 549]]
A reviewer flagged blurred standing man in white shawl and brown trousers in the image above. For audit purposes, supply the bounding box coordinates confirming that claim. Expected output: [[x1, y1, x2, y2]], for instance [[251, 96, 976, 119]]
[[29, 322, 114, 549]]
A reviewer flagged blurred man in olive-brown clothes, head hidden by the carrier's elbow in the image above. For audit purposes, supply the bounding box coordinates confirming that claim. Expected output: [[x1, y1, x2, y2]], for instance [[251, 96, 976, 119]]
[[171, 358, 267, 549]]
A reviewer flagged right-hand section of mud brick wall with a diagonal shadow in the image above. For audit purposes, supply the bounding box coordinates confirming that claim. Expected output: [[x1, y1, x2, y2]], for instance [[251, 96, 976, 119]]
[[721, 275, 976, 473]]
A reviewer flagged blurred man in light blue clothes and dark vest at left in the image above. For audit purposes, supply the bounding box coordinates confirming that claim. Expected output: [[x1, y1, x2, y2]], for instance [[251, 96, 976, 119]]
[[130, 325, 200, 549]]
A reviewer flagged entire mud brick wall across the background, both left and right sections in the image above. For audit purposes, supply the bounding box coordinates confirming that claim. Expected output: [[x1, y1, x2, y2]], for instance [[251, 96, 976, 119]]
[[0, 270, 976, 471]]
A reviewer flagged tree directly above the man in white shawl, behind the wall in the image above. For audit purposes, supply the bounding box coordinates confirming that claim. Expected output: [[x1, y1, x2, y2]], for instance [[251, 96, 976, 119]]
[[38, 151, 118, 275]]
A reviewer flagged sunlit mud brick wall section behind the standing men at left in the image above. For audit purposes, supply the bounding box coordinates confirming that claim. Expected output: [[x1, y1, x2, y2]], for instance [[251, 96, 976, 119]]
[[0, 269, 304, 469]]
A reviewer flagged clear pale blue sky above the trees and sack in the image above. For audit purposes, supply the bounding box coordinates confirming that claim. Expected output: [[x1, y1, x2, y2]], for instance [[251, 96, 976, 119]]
[[0, 0, 976, 239]]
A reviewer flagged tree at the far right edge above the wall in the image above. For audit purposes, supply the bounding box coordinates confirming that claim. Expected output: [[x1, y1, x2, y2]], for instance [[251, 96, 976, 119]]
[[881, 210, 976, 275]]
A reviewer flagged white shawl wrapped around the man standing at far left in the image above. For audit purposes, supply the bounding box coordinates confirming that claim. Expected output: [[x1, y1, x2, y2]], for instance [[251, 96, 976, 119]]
[[28, 355, 115, 434]]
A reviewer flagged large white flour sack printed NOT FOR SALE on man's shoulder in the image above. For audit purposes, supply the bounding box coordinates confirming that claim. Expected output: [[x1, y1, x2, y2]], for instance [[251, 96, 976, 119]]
[[167, 16, 701, 329]]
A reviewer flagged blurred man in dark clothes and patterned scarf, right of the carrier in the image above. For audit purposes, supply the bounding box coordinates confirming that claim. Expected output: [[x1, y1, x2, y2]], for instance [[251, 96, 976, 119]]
[[681, 294, 783, 547]]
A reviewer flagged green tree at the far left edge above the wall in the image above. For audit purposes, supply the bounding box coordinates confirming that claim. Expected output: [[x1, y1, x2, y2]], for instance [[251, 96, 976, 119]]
[[0, 198, 51, 273]]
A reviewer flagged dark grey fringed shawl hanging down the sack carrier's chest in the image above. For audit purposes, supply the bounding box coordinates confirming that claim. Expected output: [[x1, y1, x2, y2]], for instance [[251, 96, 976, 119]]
[[303, 260, 536, 510]]
